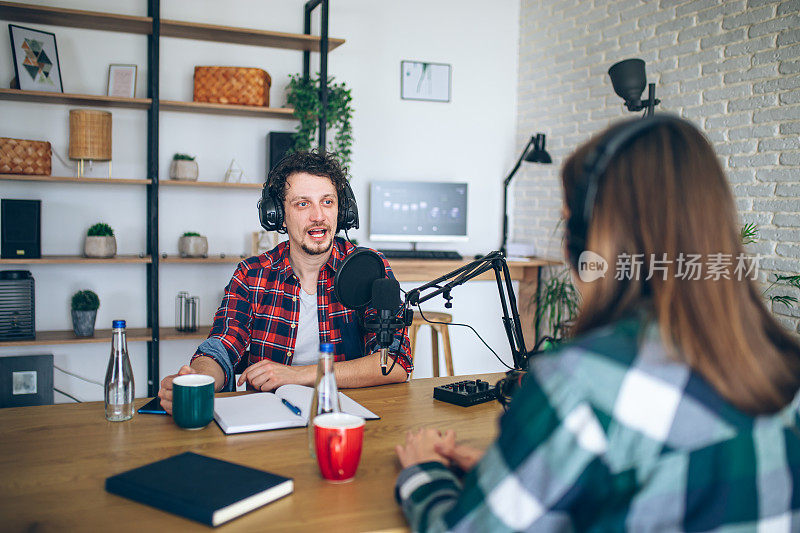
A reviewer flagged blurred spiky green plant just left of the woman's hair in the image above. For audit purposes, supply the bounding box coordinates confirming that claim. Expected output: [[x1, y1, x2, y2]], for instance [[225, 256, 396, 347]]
[[535, 268, 581, 340]]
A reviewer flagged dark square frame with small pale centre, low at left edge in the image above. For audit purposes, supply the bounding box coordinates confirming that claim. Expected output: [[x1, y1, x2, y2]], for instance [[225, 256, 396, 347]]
[[0, 354, 53, 407]]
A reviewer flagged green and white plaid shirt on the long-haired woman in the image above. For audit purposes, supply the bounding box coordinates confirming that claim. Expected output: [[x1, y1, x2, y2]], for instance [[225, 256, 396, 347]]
[[396, 319, 800, 532]]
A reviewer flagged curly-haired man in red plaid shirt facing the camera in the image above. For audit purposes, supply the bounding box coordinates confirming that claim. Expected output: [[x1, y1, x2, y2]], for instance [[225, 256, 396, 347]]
[[158, 152, 413, 413]]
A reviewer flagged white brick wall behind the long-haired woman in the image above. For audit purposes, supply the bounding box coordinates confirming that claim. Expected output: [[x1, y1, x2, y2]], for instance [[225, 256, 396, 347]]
[[510, 0, 800, 331]]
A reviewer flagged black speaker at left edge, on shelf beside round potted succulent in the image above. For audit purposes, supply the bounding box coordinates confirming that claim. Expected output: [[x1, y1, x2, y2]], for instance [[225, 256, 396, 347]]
[[0, 199, 42, 259]]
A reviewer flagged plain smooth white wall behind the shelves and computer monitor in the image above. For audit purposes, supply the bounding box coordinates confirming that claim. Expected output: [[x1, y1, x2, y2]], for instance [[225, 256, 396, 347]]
[[0, 0, 519, 401]]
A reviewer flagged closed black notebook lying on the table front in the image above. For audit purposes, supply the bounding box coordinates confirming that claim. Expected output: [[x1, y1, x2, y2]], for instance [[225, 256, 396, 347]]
[[106, 452, 294, 526]]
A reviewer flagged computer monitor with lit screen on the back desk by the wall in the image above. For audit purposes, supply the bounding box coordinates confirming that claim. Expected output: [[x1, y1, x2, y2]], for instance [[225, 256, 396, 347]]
[[369, 181, 467, 242]]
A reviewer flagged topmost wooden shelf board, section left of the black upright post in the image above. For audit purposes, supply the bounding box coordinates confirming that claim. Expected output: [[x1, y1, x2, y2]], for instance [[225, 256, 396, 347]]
[[0, 2, 153, 35]]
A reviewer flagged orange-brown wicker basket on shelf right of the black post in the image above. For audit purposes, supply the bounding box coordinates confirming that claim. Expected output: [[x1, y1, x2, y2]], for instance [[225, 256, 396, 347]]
[[194, 67, 272, 107]]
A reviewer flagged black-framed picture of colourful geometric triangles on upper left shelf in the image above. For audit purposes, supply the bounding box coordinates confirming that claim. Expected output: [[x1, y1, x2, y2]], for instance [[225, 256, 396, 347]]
[[8, 24, 64, 93]]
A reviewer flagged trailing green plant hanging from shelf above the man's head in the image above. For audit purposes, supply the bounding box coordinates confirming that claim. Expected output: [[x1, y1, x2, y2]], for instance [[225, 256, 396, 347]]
[[286, 74, 353, 165]]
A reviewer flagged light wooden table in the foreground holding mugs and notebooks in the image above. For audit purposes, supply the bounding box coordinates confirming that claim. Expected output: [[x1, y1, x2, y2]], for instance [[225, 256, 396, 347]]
[[0, 374, 503, 531]]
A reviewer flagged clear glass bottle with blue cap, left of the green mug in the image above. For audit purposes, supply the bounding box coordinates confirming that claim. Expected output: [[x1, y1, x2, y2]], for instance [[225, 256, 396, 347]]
[[104, 320, 133, 422]]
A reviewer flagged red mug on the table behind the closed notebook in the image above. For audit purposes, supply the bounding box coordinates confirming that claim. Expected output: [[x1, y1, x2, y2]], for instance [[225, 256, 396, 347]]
[[314, 413, 364, 483]]
